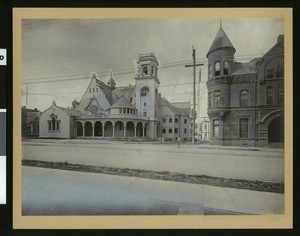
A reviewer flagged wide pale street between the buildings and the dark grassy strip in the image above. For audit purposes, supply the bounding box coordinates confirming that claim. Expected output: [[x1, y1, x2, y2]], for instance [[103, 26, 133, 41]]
[[22, 140, 284, 183]]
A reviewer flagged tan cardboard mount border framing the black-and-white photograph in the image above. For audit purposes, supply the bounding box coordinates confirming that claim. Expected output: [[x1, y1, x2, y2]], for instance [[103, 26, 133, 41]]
[[13, 8, 293, 229]]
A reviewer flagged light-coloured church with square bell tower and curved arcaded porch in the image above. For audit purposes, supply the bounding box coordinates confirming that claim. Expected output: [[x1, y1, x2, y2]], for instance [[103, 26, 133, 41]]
[[40, 53, 190, 139]]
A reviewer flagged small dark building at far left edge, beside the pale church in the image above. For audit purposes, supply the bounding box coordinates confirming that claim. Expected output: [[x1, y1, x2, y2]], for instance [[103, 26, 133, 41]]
[[22, 106, 41, 137]]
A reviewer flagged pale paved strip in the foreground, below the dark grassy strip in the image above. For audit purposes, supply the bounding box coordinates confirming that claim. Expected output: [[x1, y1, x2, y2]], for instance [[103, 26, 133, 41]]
[[22, 166, 284, 215]]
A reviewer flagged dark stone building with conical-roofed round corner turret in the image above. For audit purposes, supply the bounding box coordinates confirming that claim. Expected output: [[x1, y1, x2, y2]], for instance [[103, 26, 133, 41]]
[[206, 24, 284, 146]]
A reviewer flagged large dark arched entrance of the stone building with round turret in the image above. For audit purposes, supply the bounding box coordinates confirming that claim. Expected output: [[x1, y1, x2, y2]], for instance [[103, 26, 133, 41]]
[[268, 116, 284, 143]]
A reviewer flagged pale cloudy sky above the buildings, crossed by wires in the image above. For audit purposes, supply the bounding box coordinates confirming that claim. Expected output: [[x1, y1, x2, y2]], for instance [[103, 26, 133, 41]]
[[22, 18, 284, 120]]
